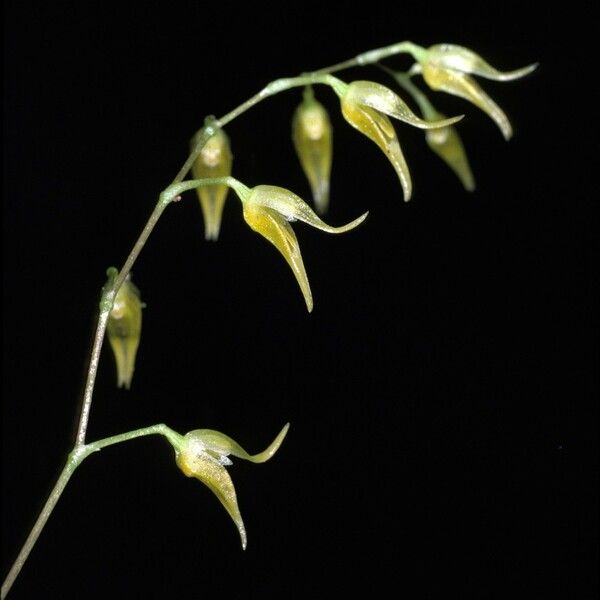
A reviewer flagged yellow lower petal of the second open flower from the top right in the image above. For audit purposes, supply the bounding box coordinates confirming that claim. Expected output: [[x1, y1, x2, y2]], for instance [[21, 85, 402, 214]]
[[342, 96, 412, 201]]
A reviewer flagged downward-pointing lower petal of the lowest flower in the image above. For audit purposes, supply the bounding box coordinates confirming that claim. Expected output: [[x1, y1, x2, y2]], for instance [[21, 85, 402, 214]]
[[176, 446, 247, 550]]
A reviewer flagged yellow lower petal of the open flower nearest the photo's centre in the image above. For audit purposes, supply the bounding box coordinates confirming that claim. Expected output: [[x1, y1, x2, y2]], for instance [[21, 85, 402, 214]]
[[243, 203, 313, 312]]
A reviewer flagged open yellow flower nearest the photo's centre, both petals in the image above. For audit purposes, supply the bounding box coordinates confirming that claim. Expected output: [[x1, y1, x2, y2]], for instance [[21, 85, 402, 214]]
[[236, 185, 368, 312]]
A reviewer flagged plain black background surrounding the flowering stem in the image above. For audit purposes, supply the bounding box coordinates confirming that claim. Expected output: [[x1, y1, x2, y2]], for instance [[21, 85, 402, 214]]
[[2, 2, 598, 599]]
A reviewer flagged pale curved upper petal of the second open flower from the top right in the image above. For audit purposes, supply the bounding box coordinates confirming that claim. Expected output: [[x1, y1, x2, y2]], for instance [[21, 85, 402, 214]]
[[344, 81, 462, 129]]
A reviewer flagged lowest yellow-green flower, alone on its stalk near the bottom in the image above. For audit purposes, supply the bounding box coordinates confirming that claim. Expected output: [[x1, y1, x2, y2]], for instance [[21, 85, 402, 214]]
[[175, 423, 290, 550]]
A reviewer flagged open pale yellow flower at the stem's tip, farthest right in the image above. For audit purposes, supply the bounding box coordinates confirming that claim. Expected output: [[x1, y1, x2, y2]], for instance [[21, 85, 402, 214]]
[[415, 44, 537, 140]]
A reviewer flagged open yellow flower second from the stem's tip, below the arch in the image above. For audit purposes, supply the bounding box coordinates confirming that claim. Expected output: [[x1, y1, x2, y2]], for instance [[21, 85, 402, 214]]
[[334, 81, 462, 201]]
